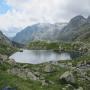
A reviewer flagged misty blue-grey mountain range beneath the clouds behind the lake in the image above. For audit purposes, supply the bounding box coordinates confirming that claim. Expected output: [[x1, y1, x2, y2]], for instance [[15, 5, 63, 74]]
[[0, 15, 90, 46]]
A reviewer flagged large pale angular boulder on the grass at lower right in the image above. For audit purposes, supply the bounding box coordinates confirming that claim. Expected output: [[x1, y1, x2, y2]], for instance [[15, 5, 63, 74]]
[[60, 71, 75, 83]]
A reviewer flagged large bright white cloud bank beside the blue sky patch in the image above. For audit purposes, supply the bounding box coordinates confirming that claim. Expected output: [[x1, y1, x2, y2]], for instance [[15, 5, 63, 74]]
[[0, 0, 66, 28]]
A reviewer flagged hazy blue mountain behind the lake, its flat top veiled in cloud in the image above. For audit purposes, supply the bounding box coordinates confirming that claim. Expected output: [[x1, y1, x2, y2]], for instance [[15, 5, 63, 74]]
[[13, 23, 66, 44]]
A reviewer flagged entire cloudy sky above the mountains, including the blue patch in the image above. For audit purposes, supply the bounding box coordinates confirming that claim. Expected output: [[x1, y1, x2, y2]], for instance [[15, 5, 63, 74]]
[[0, 0, 90, 35]]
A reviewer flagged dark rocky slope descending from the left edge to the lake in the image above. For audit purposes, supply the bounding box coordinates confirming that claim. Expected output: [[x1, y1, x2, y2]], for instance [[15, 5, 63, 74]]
[[0, 31, 18, 55]]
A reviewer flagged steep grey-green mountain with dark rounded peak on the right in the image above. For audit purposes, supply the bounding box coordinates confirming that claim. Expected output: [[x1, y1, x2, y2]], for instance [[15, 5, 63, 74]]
[[59, 15, 90, 41]]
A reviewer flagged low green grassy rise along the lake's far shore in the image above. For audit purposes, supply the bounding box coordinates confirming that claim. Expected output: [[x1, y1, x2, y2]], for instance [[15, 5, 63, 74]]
[[27, 41, 83, 51]]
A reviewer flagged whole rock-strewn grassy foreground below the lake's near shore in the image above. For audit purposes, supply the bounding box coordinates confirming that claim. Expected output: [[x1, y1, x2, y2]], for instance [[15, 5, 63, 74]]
[[0, 55, 90, 90]]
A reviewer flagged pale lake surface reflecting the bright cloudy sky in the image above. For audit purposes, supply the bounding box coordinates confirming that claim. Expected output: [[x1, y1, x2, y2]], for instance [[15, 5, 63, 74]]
[[10, 50, 71, 64]]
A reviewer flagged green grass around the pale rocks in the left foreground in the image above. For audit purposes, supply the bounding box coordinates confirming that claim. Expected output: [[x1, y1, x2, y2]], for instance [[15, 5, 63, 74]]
[[0, 63, 66, 90]]
